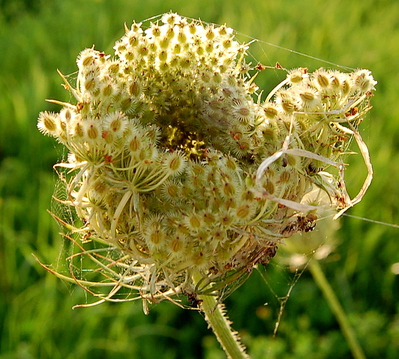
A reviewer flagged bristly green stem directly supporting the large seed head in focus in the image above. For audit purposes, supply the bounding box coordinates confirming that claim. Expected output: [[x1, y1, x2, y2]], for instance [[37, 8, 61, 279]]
[[194, 273, 249, 359]]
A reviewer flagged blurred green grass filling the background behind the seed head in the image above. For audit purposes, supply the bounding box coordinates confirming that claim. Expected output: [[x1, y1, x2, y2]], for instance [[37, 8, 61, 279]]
[[0, 0, 399, 359]]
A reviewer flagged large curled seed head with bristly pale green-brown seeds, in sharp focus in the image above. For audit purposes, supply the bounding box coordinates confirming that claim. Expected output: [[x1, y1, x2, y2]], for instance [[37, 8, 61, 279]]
[[38, 13, 376, 308]]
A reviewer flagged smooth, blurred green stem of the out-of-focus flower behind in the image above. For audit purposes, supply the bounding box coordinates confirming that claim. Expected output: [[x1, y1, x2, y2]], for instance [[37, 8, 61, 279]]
[[308, 260, 366, 359]]
